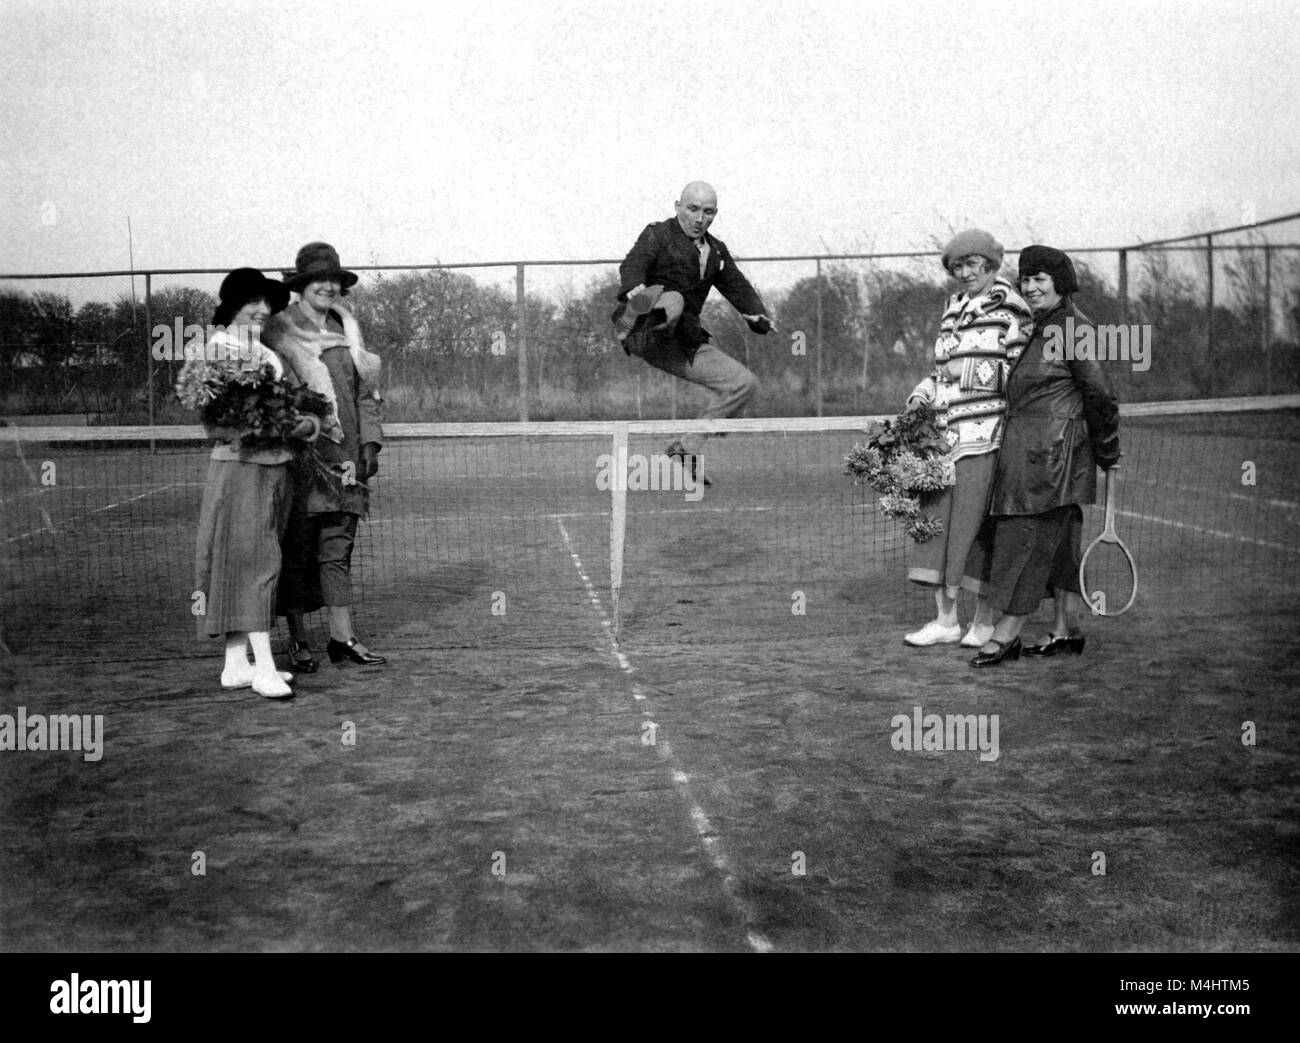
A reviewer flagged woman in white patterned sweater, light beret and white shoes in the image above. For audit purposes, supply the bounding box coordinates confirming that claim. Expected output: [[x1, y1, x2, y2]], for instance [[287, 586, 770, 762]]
[[904, 229, 1034, 648]]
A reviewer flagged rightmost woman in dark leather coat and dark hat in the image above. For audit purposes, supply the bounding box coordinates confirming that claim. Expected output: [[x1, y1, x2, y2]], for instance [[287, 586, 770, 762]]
[[967, 246, 1119, 666]]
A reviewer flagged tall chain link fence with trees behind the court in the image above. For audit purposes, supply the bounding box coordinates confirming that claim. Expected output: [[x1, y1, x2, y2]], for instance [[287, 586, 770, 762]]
[[0, 215, 1300, 425]]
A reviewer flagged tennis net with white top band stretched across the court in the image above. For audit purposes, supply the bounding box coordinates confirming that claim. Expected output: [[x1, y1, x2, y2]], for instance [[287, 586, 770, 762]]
[[0, 395, 1300, 659]]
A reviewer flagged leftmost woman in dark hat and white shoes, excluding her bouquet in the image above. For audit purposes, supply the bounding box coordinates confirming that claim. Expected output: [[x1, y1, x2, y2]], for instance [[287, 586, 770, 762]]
[[181, 268, 320, 698]]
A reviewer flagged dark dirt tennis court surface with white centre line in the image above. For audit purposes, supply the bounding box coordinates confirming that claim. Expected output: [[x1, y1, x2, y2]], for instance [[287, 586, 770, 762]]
[[0, 410, 1300, 952]]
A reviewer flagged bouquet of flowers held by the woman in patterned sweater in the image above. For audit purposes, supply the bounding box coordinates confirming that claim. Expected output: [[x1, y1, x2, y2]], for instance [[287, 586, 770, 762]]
[[844, 404, 957, 544]]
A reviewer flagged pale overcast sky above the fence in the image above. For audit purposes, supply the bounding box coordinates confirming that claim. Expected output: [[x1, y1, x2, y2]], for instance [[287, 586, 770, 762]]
[[0, 0, 1300, 272]]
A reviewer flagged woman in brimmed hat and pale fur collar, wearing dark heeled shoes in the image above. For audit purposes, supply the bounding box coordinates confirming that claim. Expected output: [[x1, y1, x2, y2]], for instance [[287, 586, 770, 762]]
[[263, 242, 385, 674]]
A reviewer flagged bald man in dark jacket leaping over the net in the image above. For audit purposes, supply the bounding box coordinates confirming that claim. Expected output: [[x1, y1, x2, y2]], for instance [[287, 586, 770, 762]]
[[614, 181, 776, 485]]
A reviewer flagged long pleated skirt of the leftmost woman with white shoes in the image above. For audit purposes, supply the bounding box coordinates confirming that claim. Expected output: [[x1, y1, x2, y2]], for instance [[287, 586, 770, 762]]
[[195, 460, 293, 637]]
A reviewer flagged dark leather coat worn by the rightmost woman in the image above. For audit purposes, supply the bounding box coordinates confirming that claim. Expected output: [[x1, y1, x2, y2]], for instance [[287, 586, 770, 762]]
[[988, 298, 1119, 515]]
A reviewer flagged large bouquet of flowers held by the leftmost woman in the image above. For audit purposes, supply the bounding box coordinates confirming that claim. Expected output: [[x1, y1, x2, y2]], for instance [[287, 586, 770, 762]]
[[176, 359, 342, 493]]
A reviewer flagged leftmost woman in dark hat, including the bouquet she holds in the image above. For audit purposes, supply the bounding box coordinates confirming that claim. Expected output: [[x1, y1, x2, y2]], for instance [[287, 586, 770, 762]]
[[184, 268, 320, 698]]
